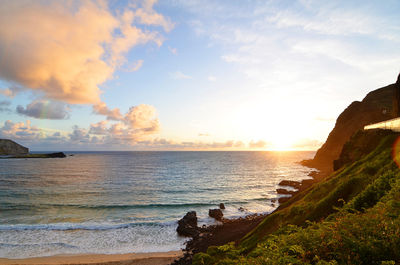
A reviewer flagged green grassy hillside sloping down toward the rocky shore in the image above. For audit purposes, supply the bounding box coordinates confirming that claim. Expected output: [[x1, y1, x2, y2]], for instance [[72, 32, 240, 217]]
[[193, 130, 400, 264]]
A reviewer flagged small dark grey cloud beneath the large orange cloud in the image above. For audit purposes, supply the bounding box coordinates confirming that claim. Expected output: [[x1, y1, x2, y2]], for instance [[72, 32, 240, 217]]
[[16, 100, 69, 120]]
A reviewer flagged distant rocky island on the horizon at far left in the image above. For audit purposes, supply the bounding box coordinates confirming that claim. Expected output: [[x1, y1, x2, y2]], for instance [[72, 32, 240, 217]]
[[0, 139, 66, 158]]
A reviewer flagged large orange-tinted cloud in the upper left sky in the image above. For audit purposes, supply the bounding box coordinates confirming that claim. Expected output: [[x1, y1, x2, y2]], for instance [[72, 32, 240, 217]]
[[0, 0, 173, 104]]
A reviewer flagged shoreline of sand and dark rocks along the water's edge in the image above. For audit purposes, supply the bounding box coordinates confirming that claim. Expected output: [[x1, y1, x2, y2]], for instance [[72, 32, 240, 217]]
[[0, 157, 318, 265]]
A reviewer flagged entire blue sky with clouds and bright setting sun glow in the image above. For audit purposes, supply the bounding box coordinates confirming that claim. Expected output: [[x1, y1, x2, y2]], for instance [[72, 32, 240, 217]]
[[0, 0, 400, 151]]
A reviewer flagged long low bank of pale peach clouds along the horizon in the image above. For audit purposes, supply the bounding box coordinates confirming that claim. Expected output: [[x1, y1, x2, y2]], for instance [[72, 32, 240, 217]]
[[0, 116, 265, 150]]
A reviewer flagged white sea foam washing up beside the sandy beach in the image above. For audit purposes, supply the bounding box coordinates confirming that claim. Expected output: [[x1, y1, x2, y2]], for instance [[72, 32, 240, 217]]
[[0, 222, 186, 258]]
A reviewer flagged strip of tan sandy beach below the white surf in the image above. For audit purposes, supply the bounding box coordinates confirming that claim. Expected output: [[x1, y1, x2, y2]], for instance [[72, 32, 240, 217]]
[[0, 251, 182, 265]]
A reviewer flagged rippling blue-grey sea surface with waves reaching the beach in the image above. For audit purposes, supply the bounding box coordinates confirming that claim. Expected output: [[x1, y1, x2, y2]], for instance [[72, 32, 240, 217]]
[[0, 152, 314, 258]]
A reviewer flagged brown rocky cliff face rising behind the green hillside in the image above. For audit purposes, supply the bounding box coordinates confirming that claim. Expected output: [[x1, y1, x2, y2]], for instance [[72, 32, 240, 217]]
[[303, 84, 395, 173]]
